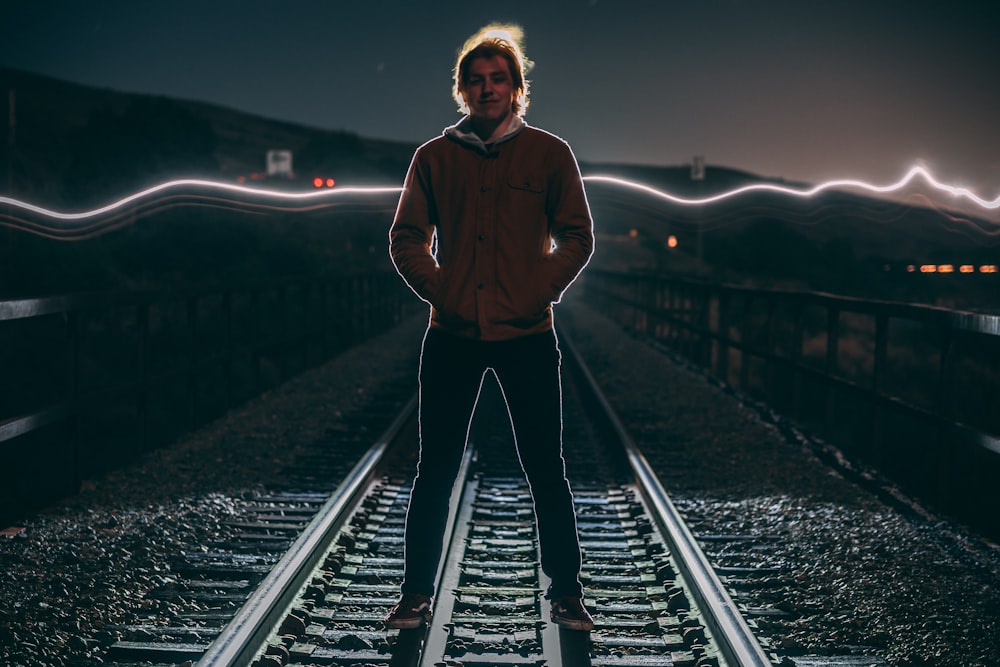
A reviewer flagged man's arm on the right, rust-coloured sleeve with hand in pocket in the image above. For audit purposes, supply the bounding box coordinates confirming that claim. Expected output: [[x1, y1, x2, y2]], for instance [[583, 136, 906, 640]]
[[547, 142, 594, 303]]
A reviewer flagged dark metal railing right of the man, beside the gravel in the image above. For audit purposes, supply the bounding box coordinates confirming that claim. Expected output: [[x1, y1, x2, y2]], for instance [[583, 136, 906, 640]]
[[583, 269, 1000, 537]]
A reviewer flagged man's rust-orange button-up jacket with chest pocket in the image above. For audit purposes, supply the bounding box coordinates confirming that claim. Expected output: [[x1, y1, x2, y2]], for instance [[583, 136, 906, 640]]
[[389, 121, 594, 340]]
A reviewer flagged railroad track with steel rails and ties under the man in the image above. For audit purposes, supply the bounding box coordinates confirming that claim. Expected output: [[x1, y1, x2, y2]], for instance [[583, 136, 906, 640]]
[[95, 337, 776, 667]]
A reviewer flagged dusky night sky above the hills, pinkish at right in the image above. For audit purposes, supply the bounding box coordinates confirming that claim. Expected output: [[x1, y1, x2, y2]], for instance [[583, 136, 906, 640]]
[[0, 0, 1000, 209]]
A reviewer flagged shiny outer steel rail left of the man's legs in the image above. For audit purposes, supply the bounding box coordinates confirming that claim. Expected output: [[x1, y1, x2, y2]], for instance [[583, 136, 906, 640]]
[[197, 396, 417, 667]]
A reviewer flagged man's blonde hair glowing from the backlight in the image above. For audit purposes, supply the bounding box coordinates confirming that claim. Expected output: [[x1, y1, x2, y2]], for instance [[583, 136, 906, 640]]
[[451, 23, 534, 116]]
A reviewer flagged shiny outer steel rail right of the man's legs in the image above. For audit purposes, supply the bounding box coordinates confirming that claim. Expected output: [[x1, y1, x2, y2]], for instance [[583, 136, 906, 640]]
[[559, 332, 774, 667]]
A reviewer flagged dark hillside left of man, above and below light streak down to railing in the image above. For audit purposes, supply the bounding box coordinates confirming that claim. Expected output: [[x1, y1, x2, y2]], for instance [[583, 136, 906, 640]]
[[0, 69, 414, 298]]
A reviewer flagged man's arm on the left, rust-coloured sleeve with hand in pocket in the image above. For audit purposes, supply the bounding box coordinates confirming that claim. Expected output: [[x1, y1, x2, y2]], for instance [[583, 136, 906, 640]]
[[389, 151, 439, 303]]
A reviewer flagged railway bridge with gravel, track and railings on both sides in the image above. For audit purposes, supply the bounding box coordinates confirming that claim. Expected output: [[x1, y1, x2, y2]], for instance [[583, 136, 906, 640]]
[[0, 269, 1000, 667]]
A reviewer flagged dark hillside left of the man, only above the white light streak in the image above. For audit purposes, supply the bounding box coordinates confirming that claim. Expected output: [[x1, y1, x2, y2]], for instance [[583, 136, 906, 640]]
[[0, 68, 414, 208]]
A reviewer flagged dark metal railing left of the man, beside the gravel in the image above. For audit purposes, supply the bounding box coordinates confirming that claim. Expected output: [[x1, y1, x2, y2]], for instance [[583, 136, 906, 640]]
[[0, 271, 422, 521]]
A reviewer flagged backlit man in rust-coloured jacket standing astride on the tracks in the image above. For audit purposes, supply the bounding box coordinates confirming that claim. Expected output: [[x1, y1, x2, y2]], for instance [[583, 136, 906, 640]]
[[385, 25, 594, 631]]
